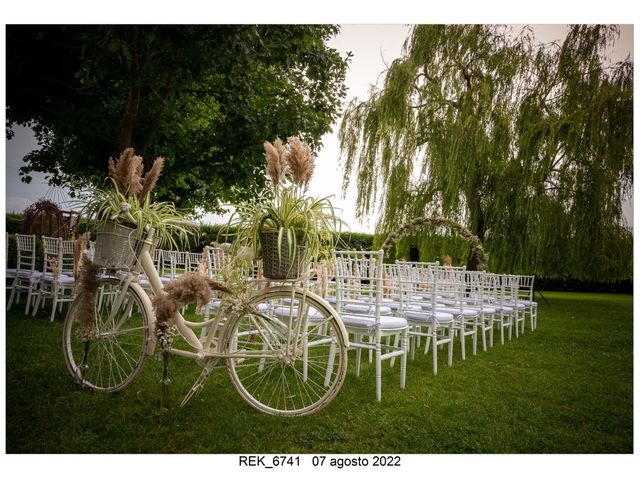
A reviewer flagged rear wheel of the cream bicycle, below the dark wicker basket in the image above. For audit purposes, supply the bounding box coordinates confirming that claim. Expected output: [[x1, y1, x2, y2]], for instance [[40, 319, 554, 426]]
[[224, 287, 347, 416]]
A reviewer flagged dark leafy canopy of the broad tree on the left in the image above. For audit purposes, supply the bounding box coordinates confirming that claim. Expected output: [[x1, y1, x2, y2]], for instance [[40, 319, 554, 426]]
[[7, 25, 348, 211]]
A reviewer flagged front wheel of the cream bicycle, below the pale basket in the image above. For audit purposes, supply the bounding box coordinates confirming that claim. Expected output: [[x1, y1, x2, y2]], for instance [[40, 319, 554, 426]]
[[63, 278, 149, 392]]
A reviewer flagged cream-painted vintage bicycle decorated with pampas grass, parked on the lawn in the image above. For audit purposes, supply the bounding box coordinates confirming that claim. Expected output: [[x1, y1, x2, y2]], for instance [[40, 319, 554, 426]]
[[63, 228, 348, 416]]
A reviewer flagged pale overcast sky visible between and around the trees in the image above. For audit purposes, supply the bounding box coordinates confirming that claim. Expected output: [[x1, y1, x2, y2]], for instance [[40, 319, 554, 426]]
[[6, 24, 633, 232]]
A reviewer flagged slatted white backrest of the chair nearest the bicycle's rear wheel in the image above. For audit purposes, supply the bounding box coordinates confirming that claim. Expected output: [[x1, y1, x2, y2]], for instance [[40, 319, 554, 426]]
[[332, 250, 384, 323]]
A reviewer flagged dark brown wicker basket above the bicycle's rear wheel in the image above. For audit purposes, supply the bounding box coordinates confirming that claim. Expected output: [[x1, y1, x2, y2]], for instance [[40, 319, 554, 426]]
[[260, 230, 306, 280]]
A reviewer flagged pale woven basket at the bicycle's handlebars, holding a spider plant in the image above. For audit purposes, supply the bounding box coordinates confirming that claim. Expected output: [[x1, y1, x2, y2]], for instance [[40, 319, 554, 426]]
[[93, 223, 142, 270]]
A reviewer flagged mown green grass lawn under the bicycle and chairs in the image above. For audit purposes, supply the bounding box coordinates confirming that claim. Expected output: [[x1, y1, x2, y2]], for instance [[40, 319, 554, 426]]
[[6, 293, 633, 453]]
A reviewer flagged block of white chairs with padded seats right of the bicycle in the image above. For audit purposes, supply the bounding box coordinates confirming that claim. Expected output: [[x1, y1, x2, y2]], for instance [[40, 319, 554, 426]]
[[323, 251, 537, 400]]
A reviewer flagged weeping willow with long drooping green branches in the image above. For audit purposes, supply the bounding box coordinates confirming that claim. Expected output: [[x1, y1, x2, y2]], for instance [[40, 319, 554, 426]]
[[340, 25, 633, 280]]
